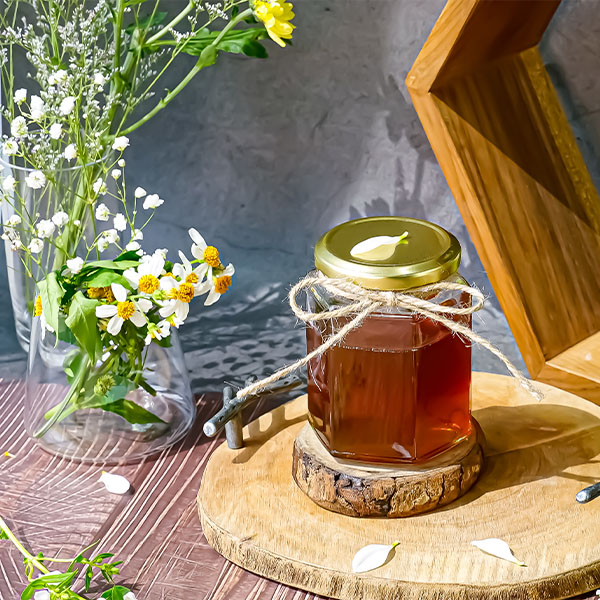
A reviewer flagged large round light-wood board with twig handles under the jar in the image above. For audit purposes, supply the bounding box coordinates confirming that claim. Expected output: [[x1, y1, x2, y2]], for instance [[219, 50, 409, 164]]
[[198, 373, 600, 600]]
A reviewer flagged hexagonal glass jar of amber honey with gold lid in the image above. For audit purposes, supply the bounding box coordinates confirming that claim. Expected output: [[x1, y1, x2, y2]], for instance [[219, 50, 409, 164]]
[[306, 217, 473, 464]]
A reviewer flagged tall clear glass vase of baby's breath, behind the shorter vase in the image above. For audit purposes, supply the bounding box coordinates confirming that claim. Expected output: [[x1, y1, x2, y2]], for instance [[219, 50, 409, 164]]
[[0, 158, 104, 352]]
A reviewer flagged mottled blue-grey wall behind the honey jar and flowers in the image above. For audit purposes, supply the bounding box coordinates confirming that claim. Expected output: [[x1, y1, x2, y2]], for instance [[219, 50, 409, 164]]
[[0, 0, 600, 391]]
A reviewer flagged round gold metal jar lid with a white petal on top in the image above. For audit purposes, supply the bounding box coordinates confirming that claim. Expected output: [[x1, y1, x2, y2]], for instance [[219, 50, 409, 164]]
[[315, 217, 460, 290]]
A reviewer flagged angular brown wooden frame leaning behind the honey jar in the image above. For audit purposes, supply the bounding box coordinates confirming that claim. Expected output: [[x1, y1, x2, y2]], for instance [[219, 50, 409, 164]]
[[406, 0, 600, 404]]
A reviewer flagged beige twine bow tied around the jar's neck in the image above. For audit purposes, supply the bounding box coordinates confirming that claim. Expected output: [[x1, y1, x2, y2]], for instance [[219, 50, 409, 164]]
[[236, 272, 543, 400]]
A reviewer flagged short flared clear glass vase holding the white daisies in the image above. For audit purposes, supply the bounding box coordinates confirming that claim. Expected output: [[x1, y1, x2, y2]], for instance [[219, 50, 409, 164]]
[[24, 318, 195, 464]]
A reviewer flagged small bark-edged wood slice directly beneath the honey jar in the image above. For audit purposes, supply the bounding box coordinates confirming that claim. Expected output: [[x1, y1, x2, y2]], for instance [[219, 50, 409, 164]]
[[292, 423, 483, 518]]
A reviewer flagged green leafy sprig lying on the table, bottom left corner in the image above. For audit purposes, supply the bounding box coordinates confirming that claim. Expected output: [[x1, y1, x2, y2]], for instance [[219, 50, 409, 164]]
[[0, 517, 135, 600]]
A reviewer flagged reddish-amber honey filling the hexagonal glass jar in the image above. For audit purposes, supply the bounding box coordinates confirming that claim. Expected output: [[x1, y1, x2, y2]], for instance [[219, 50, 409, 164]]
[[307, 314, 472, 463]]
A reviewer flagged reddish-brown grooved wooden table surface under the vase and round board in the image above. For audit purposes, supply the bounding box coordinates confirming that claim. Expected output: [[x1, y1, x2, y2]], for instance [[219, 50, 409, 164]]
[[0, 380, 595, 600]]
